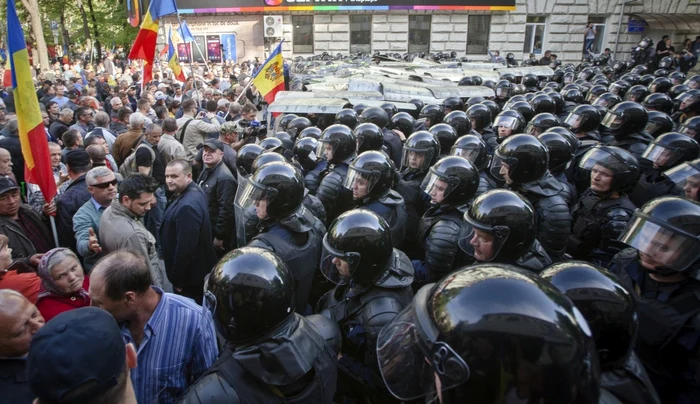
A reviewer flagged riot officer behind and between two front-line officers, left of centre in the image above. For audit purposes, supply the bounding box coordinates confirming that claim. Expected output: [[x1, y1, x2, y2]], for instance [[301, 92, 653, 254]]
[[316, 124, 356, 223]]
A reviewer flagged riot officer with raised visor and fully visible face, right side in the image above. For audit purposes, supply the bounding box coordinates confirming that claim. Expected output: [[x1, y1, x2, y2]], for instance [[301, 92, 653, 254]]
[[567, 146, 639, 266]]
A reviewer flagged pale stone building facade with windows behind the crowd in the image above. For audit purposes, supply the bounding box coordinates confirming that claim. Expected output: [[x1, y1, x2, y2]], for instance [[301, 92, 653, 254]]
[[170, 0, 700, 62]]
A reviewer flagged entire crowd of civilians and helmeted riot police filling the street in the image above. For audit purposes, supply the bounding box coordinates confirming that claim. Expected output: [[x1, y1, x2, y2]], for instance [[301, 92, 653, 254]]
[[0, 48, 700, 403]]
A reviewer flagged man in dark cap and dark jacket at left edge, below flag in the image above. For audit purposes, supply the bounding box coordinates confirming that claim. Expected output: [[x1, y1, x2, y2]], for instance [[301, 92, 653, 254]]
[[0, 177, 54, 259]]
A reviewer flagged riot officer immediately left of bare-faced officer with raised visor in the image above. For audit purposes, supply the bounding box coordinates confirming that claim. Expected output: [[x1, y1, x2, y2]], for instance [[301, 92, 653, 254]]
[[490, 135, 573, 261]]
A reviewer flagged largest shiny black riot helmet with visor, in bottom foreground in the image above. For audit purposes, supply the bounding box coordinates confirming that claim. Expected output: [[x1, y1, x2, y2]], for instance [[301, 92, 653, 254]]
[[377, 264, 599, 404]]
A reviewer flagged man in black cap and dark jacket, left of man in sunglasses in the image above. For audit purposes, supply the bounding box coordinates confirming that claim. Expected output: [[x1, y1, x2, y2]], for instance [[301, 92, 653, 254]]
[[56, 150, 92, 251]]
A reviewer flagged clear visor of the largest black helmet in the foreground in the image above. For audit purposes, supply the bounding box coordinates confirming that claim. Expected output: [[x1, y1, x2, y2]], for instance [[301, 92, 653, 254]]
[[377, 284, 469, 401]]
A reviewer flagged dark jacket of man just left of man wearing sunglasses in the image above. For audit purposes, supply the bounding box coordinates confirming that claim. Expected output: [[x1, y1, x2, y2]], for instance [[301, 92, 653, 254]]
[[56, 173, 92, 253]]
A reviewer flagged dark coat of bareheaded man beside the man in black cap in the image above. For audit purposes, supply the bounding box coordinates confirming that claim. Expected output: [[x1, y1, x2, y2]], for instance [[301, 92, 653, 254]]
[[160, 182, 216, 288]]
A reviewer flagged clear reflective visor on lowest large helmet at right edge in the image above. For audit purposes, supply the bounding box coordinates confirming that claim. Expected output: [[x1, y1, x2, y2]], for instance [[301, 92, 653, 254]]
[[620, 217, 700, 271]]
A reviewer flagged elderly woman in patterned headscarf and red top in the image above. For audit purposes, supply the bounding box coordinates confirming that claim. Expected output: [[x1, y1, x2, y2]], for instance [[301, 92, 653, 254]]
[[36, 248, 90, 321]]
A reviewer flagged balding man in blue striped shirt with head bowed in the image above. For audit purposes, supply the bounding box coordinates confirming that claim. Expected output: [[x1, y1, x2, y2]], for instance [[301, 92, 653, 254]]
[[89, 251, 218, 404]]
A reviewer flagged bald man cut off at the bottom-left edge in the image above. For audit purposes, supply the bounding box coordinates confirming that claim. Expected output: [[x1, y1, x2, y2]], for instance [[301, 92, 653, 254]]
[[0, 289, 44, 404]]
